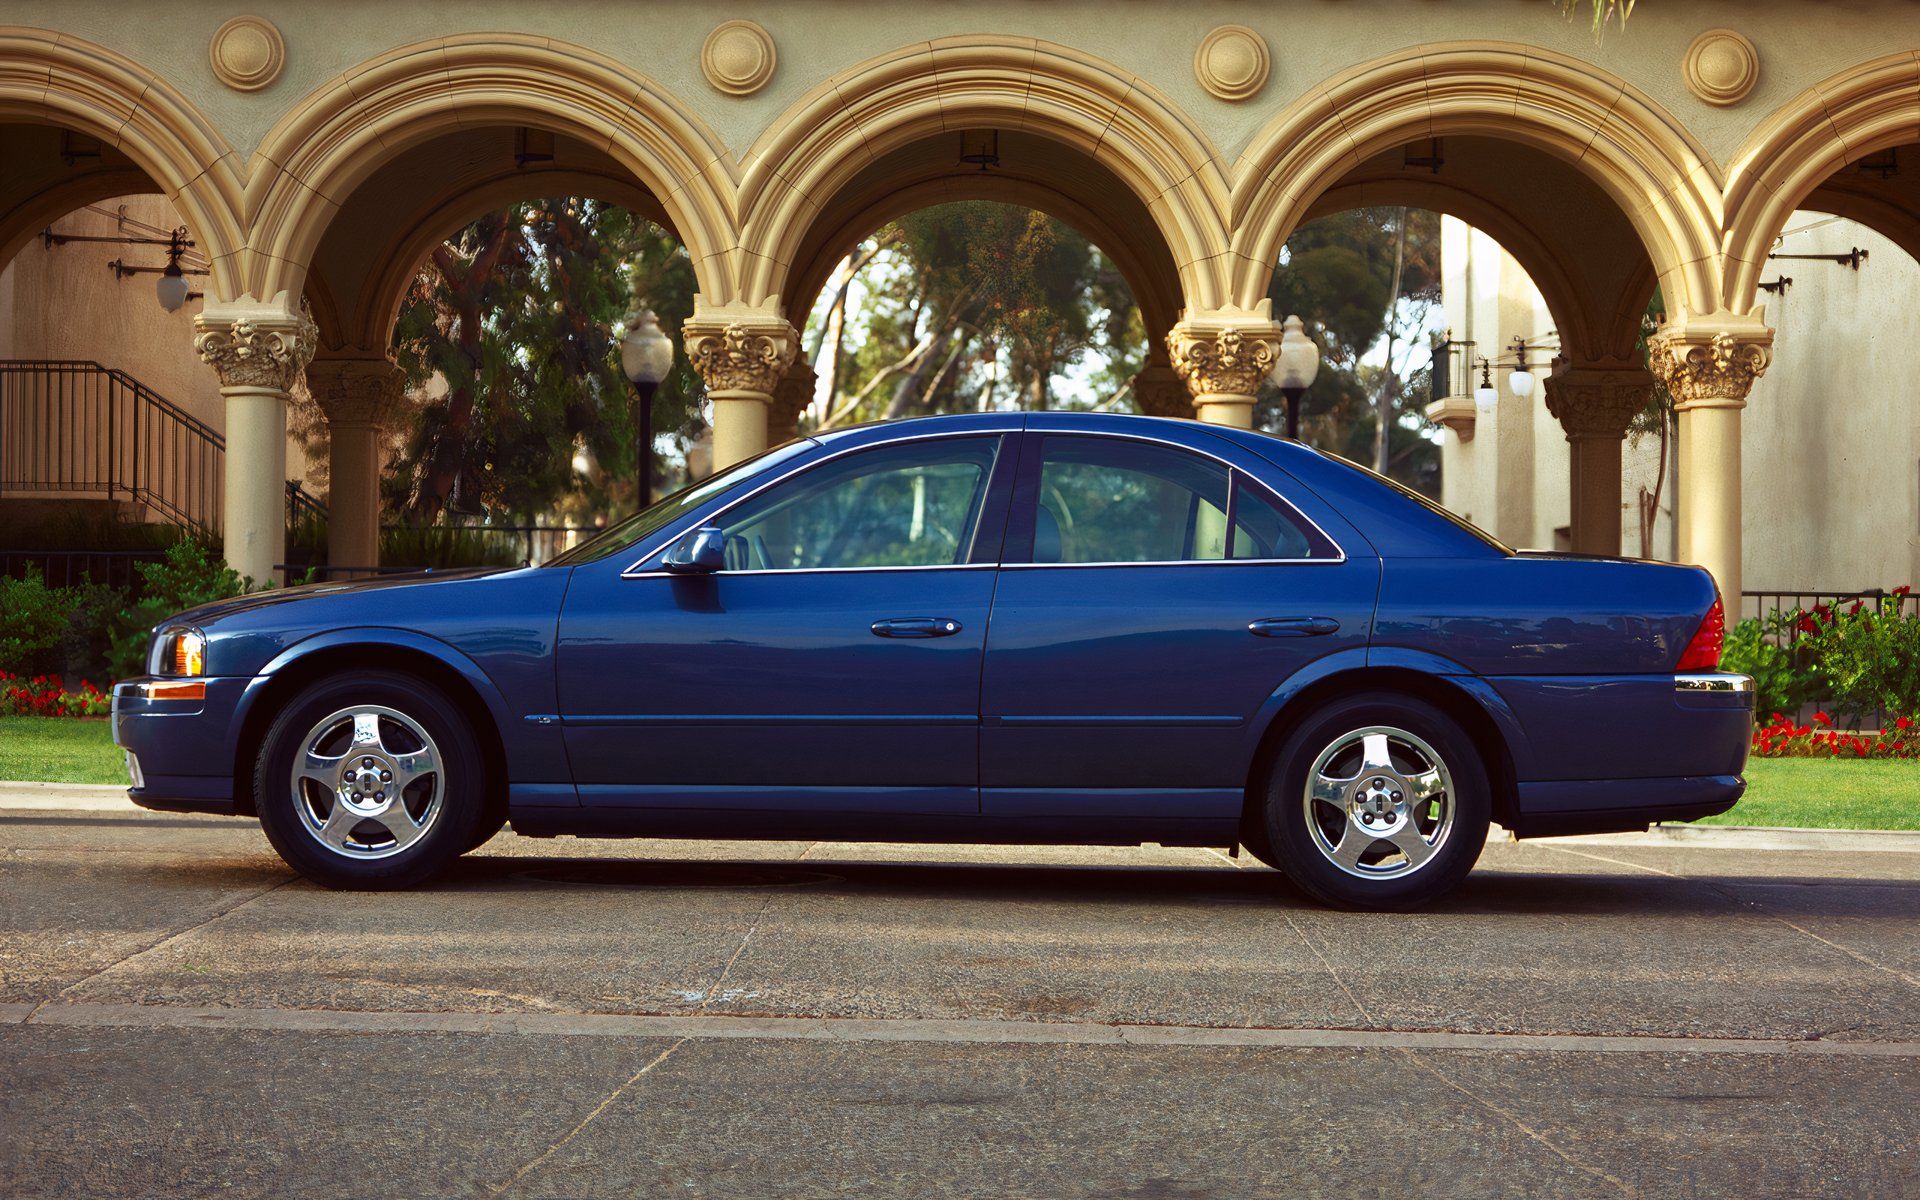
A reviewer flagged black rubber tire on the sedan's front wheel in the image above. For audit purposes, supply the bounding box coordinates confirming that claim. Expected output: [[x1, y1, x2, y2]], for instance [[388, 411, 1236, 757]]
[[253, 670, 492, 891]]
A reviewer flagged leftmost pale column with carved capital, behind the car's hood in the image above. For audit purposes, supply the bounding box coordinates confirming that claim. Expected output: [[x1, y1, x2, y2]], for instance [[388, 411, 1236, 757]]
[[194, 296, 317, 586]]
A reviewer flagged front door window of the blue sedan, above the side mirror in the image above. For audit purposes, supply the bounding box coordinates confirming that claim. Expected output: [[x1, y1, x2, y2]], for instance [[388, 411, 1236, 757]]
[[716, 436, 1000, 570]]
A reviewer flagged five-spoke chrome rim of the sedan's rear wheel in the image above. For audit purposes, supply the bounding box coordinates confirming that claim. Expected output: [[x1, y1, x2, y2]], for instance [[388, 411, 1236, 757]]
[[1304, 726, 1453, 879]]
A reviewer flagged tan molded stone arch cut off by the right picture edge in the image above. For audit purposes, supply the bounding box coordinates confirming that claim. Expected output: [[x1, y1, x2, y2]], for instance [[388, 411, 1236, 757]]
[[1722, 50, 1920, 313]]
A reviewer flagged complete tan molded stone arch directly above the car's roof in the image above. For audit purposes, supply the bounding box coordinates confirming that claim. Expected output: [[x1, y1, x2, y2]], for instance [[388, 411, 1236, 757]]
[[737, 36, 1227, 307]]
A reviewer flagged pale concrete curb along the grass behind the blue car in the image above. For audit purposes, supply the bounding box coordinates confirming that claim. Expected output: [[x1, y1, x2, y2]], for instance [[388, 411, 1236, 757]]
[[0, 780, 1920, 854]]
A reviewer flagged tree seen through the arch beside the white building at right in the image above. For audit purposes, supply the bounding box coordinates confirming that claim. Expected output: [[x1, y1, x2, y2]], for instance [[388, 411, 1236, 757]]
[[1256, 207, 1440, 492]]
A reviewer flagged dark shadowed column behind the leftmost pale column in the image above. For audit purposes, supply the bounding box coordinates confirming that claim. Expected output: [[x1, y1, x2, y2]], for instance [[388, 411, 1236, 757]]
[[307, 359, 407, 566]]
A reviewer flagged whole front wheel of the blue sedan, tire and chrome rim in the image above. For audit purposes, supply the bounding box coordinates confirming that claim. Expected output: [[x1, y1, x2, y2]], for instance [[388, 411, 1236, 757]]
[[253, 670, 488, 889]]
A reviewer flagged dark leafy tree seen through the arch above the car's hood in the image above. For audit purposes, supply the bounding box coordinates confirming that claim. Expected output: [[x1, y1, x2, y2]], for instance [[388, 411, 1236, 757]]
[[386, 196, 703, 524]]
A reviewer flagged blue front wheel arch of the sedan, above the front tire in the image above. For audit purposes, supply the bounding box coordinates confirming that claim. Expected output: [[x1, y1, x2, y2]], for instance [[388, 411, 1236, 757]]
[[232, 630, 507, 816]]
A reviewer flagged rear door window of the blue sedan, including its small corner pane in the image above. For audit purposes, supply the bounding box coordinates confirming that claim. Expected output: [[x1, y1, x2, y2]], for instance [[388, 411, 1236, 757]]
[[1033, 434, 1323, 563]]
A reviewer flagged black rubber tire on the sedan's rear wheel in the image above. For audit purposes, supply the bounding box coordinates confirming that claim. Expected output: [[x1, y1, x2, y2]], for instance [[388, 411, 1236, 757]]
[[1261, 691, 1492, 912]]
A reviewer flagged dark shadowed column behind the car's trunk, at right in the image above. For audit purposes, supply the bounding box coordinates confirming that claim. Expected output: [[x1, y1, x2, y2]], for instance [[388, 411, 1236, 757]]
[[1546, 359, 1653, 555]]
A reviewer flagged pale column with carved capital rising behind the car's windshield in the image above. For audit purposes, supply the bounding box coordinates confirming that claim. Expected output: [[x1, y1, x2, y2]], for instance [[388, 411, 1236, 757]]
[[682, 305, 801, 470]]
